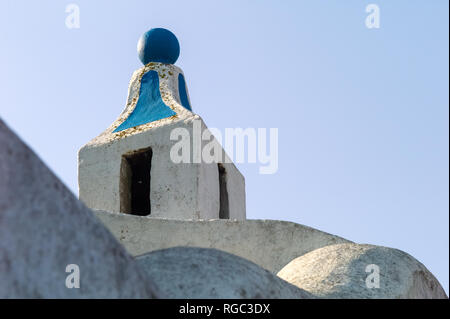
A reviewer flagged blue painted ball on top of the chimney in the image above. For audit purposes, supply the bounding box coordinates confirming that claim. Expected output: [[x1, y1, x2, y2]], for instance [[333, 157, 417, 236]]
[[138, 28, 180, 64]]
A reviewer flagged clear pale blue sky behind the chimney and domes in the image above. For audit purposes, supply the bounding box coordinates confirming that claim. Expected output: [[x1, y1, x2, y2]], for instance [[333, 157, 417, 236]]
[[0, 0, 449, 293]]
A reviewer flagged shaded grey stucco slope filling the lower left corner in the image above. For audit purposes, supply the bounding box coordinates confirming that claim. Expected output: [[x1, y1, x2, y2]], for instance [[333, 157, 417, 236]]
[[0, 120, 157, 298]]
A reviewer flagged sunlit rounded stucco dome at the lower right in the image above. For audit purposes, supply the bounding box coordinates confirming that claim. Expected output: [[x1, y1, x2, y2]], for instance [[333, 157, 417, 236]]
[[278, 244, 447, 299]]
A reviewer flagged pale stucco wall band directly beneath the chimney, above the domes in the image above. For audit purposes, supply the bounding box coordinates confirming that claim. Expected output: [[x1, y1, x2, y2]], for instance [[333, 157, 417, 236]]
[[95, 211, 349, 273]]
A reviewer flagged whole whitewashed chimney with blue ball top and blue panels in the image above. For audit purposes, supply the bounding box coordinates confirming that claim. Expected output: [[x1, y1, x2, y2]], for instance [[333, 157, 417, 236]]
[[78, 28, 246, 220]]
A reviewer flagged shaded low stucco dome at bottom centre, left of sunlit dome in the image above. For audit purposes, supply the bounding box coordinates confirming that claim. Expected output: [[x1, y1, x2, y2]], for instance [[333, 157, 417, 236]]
[[136, 247, 313, 299]]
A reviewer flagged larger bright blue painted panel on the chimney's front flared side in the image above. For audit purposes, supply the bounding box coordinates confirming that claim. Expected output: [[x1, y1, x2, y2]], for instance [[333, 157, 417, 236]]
[[114, 71, 176, 132]]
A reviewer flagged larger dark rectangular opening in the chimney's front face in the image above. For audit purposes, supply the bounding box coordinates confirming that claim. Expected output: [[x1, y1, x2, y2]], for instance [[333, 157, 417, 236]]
[[119, 148, 152, 216]]
